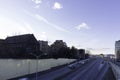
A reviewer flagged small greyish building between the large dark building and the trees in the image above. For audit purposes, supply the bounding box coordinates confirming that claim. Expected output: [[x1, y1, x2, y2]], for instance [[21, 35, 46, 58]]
[[38, 41, 49, 54]]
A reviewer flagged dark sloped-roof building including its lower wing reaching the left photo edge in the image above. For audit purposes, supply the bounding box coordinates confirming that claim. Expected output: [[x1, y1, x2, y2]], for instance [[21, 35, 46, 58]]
[[0, 34, 40, 58]]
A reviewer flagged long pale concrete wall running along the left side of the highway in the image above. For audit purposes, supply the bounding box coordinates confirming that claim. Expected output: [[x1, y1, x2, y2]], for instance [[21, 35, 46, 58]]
[[0, 59, 74, 80]]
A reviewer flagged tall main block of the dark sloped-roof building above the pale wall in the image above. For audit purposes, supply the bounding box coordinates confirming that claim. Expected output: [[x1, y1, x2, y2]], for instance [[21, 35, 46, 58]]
[[5, 34, 39, 58]]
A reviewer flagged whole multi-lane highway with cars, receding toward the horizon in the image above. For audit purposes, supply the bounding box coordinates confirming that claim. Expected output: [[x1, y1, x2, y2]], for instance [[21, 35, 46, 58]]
[[12, 58, 110, 80]]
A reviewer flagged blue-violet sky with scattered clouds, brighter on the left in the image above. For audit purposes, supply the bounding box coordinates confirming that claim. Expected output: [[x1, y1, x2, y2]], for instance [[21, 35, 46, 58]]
[[0, 0, 120, 54]]
